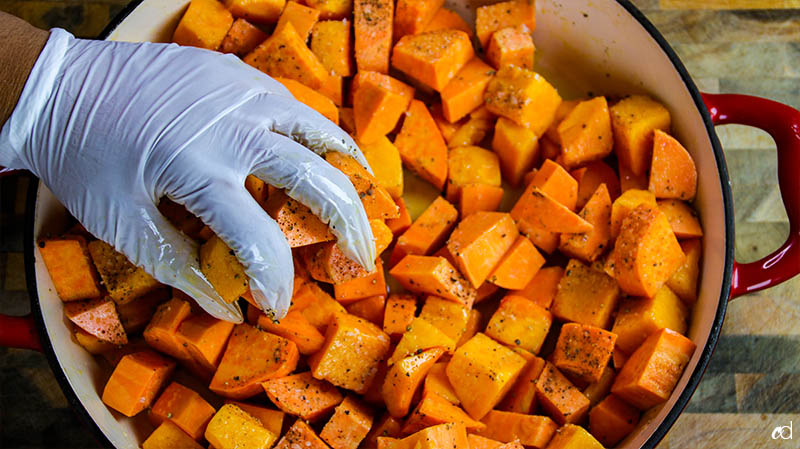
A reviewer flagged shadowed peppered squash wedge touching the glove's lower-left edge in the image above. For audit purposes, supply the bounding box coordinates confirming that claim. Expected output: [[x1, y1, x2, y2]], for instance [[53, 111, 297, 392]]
[[88, 240, 161, 304]]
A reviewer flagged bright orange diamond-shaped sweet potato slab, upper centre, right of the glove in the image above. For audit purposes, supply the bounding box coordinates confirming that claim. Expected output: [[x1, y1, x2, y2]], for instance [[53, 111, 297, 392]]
[[394, 100, 447, 190]]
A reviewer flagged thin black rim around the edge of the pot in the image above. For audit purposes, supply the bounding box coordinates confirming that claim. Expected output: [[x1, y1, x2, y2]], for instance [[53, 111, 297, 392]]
[[25, 0, 735, 449]]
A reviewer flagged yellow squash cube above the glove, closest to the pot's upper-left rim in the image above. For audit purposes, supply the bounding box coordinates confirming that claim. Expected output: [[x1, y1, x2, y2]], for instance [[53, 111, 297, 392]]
[[172, 0, 233, 50]]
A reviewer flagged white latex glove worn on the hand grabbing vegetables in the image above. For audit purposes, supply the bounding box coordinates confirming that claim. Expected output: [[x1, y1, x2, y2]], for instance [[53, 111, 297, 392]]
[[0, 29, 375, 322]]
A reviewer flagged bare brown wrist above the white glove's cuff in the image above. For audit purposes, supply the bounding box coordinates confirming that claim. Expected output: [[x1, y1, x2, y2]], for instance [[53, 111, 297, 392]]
[[0, 12, 49, 126]]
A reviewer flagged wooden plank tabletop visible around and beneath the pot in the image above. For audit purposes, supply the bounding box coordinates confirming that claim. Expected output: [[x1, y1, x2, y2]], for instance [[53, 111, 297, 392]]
[[0, 0, 800, 449]]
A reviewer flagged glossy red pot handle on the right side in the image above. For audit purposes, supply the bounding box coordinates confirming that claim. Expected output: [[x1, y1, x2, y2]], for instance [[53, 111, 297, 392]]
[[703, 94, 800, 299]]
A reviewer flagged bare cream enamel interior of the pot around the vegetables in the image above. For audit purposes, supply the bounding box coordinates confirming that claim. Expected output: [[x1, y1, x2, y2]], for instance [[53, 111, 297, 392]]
[[34, 0, 726, 448]]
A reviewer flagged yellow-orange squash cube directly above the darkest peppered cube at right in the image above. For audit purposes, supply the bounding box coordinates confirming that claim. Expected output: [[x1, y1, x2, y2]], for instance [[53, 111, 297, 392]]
[[550, 259, 619, 329]]
